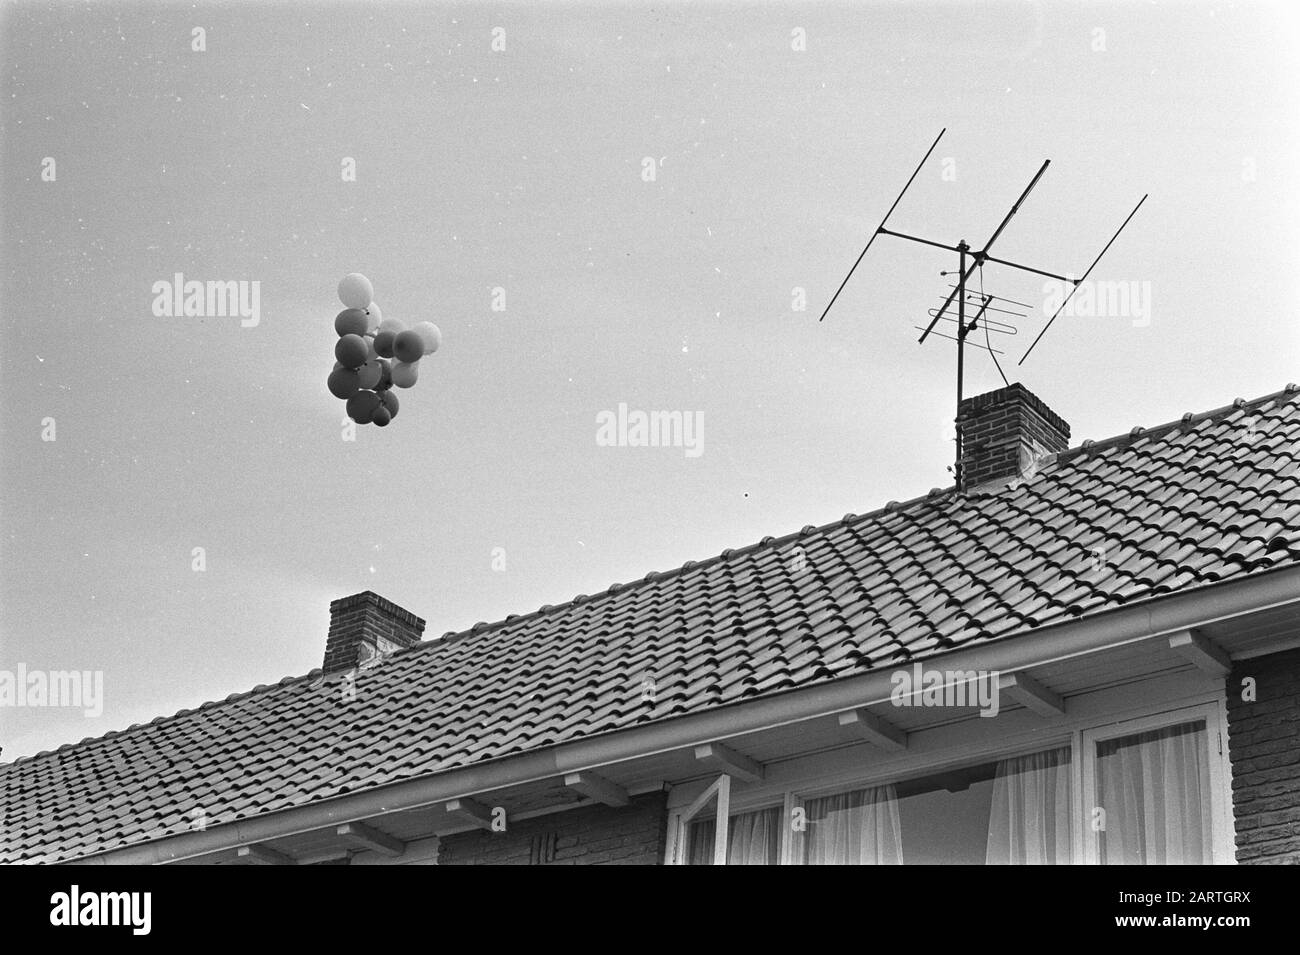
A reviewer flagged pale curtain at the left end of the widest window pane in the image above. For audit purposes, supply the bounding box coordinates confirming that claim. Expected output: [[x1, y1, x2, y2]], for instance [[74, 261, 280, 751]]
[[802, 783, 902, 865]]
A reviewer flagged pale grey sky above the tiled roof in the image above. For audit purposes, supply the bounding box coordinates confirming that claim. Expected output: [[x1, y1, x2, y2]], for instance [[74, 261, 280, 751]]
[[0, 1, 1300, 761]]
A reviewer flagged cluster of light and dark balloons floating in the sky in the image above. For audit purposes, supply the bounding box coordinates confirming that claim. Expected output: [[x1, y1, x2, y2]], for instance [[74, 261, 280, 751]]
[[329, 272, 442, 427]]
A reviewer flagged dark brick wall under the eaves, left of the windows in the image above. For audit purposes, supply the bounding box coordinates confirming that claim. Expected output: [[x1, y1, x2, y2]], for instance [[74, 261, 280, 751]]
[[438, 793, 668, 865]]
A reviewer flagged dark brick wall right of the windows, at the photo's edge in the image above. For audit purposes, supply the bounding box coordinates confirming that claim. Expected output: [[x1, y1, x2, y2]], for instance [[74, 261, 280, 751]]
[[1227, 650, 1300, 864]]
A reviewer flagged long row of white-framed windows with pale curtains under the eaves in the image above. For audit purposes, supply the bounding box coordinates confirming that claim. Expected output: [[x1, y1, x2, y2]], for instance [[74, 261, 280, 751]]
[[671, 698, 1234, 865]]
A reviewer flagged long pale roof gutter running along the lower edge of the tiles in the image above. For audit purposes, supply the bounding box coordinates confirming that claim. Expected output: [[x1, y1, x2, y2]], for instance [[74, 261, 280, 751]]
[[78, 567, 1300, 865]]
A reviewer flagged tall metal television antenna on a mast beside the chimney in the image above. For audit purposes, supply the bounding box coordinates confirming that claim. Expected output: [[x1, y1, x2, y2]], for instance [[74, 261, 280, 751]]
[[818, 126, 1149, 491]]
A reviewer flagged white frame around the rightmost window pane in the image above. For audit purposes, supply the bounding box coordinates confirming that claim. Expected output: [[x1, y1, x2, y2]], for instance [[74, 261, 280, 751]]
[[1075, 703, 1236, 865]]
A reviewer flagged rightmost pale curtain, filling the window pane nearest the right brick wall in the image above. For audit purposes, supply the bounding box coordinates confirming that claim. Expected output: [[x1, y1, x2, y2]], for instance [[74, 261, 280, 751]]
[[1097, 720, 1213, 865]]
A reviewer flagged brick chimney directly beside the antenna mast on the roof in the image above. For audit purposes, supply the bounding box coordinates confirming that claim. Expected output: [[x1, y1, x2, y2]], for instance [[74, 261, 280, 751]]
[[957, 383, 1070, 491]]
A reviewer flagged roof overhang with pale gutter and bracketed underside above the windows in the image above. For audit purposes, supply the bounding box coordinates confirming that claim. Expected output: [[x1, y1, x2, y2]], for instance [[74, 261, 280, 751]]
[[70, 567, 1300, 864]]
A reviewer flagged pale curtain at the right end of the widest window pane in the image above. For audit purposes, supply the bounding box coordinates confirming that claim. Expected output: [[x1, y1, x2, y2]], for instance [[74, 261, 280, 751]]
[[984, 746, 1073, 865]]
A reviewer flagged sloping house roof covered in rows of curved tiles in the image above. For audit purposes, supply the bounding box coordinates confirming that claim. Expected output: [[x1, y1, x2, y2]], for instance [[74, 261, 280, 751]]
[[0, 386, 1300, 861]]
